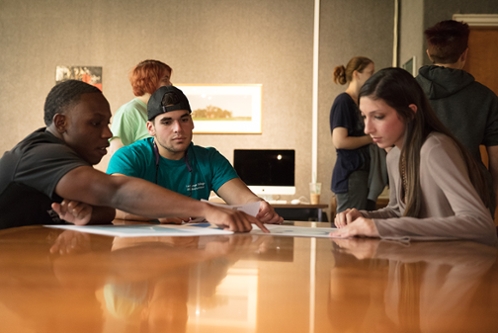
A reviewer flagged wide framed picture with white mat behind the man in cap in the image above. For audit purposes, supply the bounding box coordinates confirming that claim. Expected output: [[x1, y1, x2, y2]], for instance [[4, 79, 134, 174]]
[[175, 84, 262, 134]]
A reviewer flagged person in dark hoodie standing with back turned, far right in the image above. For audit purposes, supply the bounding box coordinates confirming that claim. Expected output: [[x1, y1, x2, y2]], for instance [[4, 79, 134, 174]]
[[417, 20, 498, 212]]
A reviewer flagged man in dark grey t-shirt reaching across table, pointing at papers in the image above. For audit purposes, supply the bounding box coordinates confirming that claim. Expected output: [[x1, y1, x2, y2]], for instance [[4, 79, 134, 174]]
[[0, 80, 267, 231]]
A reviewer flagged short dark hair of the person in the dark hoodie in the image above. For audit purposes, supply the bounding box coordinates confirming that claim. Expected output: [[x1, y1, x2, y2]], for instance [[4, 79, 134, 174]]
[[424, 20, 470, 64]]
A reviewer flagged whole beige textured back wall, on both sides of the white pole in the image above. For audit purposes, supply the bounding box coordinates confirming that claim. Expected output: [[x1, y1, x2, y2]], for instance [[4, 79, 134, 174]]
[[0, 0, 394, 215]]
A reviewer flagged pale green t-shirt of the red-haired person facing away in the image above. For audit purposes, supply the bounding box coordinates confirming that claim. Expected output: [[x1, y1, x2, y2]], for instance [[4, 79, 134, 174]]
[[111, 98, 150, 146]]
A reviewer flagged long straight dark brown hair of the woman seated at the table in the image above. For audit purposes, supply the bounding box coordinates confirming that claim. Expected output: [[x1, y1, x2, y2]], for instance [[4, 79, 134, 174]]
[[359, 68, 490, 217]]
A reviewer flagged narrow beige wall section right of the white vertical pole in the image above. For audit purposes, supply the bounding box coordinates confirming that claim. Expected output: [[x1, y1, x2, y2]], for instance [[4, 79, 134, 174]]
[[318, 0, 394, 210]]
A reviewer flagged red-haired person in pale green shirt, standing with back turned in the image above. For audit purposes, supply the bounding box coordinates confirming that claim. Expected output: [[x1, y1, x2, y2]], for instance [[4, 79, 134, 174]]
[[109, 60, 172, 154]]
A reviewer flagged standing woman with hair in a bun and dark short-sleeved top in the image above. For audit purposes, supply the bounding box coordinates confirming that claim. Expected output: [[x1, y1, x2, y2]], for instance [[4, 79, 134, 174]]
[[330, 57, 375, 212]]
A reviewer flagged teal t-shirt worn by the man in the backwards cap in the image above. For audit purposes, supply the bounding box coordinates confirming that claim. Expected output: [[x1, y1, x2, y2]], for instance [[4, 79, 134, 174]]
[[107, 137, 238, 200]]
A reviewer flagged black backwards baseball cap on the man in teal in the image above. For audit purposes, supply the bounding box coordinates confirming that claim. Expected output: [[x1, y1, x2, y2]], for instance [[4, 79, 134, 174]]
[[147, 86, 192, 120]]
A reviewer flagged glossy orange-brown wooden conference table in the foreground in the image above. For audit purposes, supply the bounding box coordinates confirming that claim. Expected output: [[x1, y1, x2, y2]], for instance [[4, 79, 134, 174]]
[[0, 222, 498, 333]]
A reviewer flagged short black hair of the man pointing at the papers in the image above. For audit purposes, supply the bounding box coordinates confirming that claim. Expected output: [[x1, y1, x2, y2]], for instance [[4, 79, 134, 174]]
[[43, 80, 102, 126]]
